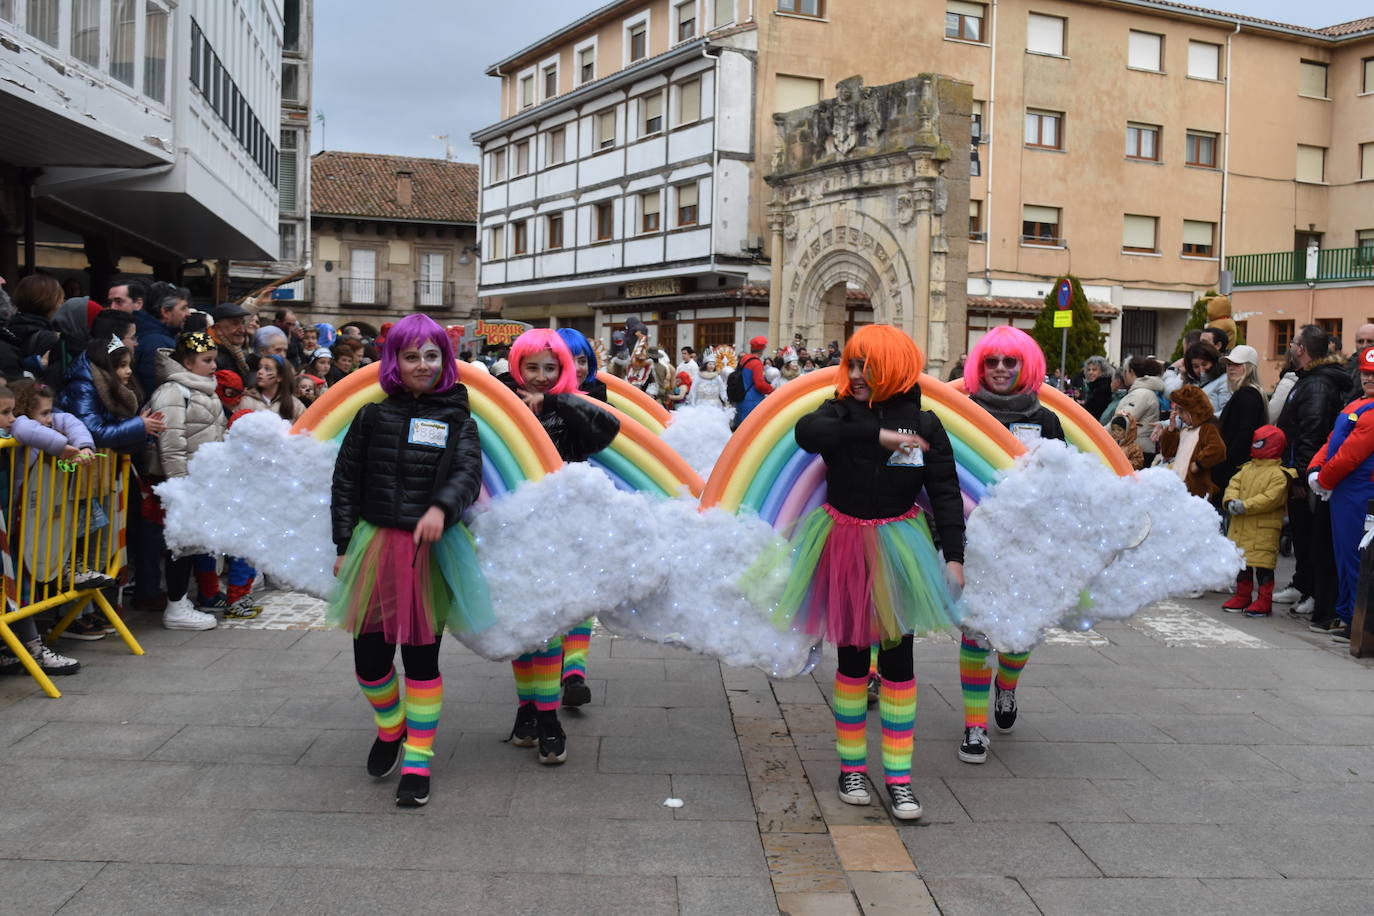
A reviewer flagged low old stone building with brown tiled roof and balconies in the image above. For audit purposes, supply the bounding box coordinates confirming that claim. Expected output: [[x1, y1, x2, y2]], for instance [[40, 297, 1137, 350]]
[[309, 152, 478, 331]]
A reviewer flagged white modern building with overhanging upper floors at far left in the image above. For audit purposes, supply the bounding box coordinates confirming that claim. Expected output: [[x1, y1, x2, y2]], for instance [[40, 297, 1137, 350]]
[[0, 0, 283, 295]]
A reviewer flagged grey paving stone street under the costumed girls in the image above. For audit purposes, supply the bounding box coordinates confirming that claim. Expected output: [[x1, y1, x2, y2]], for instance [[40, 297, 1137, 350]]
[[0, 554, 1374, 916]]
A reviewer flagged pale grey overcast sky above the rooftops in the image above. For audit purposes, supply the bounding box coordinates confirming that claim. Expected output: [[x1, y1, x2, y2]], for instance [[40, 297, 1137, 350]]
[[312, 0, 1371, 162]]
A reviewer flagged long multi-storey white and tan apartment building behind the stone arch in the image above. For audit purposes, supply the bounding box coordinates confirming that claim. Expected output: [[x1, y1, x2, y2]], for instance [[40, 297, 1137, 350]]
[[474, 0, 1374, 373]]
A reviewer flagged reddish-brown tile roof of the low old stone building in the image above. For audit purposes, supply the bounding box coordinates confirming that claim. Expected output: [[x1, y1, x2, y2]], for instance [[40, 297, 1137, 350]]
[[311, 151, 478, 222]]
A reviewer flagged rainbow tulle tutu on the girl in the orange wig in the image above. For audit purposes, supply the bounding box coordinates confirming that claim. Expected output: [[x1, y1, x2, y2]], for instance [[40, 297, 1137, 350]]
[[774, 503, 960, 645]]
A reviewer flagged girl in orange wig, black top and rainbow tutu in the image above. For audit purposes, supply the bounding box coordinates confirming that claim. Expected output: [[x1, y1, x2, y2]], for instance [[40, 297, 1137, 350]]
[[776, 324, 963, 820]]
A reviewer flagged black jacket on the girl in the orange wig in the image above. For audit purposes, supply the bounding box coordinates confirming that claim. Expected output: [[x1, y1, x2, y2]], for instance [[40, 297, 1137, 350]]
[[796, 387, 963, 563]]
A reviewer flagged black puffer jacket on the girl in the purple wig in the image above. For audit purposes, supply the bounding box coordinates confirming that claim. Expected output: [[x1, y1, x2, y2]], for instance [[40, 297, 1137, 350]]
[[330, 385, 482, 555]]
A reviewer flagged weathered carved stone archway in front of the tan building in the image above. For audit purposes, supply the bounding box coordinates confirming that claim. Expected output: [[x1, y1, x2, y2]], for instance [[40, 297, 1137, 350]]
[[768, 76, 971, 365]]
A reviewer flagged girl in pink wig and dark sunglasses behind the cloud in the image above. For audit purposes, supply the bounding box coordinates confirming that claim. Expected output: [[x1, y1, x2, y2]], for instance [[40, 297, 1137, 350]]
[[959, 325, 1063, 764]]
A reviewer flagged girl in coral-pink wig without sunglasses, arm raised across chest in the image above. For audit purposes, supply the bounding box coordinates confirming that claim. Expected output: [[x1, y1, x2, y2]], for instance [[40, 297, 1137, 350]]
[[497, 328, 620, 765]]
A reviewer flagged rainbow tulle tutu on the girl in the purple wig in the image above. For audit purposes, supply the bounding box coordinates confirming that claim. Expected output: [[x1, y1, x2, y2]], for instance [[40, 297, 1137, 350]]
[[324, 519, 496, 645]]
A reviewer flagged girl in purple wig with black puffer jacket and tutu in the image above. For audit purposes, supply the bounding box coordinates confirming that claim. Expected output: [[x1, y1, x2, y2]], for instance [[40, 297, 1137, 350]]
[[327, 314, 493, 808]]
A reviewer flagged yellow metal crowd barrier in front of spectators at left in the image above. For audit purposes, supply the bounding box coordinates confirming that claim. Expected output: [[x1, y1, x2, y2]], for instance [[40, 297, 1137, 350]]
[[0, 439, 143, 698]]
